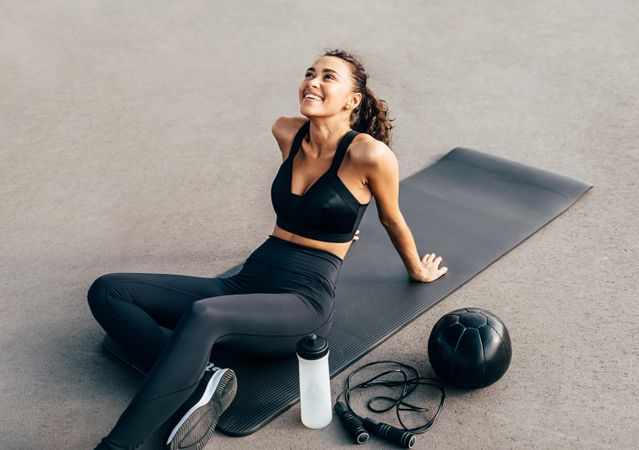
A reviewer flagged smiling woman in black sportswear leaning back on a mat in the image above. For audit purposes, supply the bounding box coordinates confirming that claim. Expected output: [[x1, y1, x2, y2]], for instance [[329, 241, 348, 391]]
[[88, 50, 447, 449]]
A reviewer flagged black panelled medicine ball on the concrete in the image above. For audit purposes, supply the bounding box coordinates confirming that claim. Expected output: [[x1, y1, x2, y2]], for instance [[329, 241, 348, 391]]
[[428, 308, 512, 389]]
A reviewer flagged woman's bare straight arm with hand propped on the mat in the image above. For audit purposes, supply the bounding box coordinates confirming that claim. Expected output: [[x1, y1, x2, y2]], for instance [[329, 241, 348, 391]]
[[367, 141, 448, 282]]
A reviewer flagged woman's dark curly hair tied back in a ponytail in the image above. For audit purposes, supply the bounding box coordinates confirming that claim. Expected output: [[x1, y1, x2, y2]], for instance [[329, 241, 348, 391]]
[[323, 49, 393, 147]]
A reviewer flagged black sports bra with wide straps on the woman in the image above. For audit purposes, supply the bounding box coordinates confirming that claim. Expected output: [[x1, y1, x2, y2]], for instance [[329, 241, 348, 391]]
[[271, 122, 370, 242]]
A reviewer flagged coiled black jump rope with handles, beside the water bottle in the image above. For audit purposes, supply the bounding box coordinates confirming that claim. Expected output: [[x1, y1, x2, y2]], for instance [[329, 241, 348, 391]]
[[335, 361, 446, 448]]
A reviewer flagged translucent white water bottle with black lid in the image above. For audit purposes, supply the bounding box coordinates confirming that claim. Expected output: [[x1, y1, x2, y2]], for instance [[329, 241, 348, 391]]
[[297, 334, 333, 428]]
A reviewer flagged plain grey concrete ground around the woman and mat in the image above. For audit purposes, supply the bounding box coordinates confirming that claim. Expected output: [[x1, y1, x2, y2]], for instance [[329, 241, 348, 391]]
[[0, 0, 639, 449]]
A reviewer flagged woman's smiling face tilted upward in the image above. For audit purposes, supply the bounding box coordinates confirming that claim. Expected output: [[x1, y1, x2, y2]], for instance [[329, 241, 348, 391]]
[[299, 56, 361, 119]]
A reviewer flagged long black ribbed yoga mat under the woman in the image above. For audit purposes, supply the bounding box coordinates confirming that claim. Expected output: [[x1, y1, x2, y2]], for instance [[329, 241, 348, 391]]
[[186, 148, 591, 436]]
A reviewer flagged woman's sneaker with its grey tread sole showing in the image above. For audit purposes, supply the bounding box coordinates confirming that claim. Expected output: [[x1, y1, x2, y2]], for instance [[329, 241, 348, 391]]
[[166, 369, 237, 450]]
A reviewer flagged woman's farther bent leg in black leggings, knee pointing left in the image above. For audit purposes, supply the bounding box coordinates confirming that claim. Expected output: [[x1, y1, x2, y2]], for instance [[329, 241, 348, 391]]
[[87, 273, 242, 373]]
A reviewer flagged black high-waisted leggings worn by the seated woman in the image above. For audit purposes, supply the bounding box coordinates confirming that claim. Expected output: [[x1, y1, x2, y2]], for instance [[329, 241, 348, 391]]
[[88, 236, 342, 448]]
